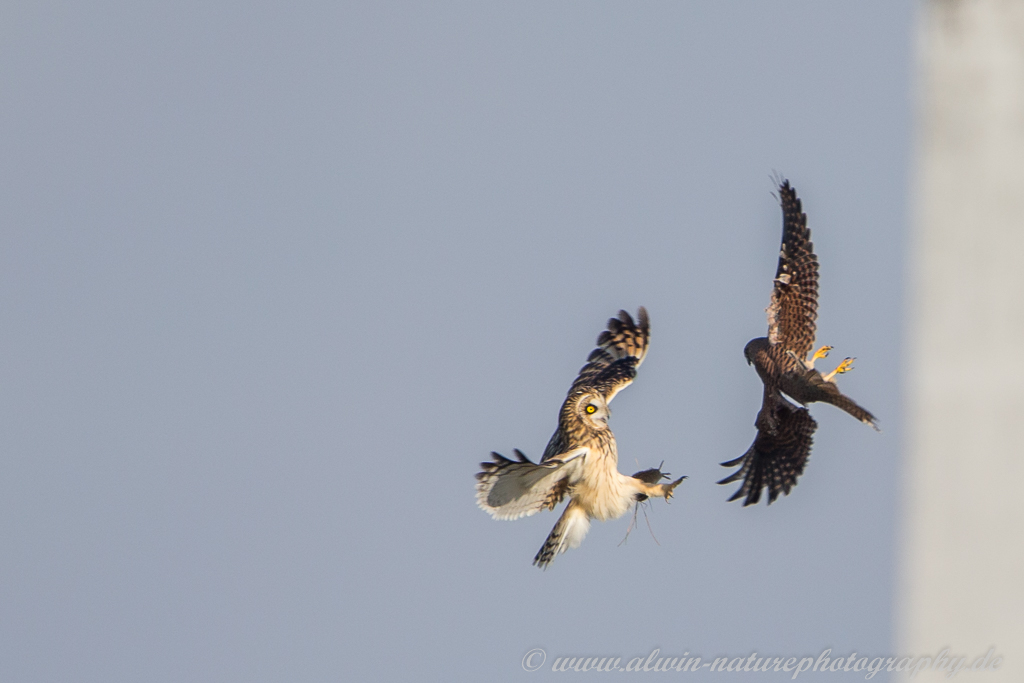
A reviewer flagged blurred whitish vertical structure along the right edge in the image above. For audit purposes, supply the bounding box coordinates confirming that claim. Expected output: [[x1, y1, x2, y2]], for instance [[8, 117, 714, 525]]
[[897, 0, 1024, 683]]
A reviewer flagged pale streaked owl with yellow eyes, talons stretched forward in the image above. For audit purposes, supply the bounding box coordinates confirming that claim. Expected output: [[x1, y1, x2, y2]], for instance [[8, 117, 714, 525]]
[[476, 307, 686, 568]]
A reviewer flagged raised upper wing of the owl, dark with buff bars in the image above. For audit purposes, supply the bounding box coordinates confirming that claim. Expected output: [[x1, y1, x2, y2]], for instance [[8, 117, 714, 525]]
[[569, 306, 650, 403]]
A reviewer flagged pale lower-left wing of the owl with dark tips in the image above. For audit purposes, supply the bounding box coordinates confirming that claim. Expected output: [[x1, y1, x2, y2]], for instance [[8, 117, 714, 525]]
[[476, 450, 586, 519]]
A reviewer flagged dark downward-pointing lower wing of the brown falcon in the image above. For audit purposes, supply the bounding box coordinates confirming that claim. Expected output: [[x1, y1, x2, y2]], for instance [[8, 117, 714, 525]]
[[719, 392, 818, 506]]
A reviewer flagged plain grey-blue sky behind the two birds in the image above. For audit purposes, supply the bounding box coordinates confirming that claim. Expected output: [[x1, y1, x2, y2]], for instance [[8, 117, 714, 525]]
[[0, 0, 914, 683]]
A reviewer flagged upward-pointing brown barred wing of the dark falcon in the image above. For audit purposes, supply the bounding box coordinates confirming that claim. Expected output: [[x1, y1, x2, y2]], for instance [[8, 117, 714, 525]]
[[768, 180, 818, 360]]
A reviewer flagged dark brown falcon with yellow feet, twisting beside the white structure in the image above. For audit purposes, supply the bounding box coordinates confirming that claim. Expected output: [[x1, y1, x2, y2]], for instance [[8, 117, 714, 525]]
[[719, 180, 878, 506]]
